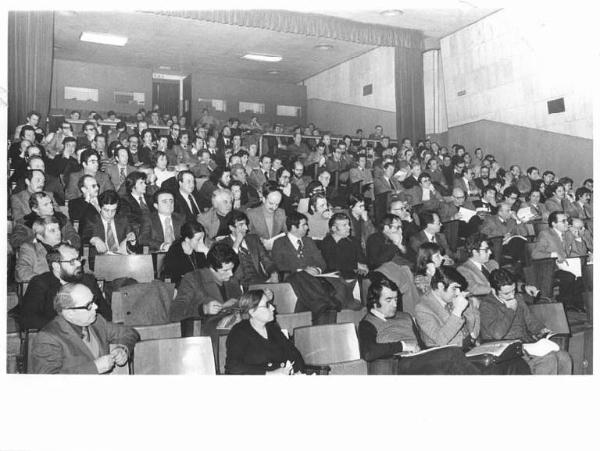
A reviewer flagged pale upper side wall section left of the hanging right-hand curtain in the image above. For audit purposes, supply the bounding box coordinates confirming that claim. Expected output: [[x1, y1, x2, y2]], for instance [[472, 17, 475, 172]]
[[304, 47, 396, 112]]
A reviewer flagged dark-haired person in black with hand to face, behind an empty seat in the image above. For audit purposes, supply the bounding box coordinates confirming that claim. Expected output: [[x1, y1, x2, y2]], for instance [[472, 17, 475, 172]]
[[163, 221, 208, 287]]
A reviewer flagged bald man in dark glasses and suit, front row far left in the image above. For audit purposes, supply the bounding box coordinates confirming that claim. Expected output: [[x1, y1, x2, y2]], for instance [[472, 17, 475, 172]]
[[31, 283, 140, 374]]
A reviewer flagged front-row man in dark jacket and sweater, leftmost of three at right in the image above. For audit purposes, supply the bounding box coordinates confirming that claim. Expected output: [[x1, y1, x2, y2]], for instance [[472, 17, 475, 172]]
[[358, 277, 480, 375]]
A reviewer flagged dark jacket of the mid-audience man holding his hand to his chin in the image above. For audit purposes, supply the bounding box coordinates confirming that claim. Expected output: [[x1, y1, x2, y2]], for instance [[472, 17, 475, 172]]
[[222, 233, 277, 287]]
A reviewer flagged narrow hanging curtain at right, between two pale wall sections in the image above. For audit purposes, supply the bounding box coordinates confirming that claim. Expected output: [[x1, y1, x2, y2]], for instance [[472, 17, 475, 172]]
[[396, 47, 425, 145]]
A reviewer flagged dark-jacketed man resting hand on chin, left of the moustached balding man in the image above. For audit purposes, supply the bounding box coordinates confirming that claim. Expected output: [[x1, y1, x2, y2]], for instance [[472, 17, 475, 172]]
[[220, 210, 279, 289]]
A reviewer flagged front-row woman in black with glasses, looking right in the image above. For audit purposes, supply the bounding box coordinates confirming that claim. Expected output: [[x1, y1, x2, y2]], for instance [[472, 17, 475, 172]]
[[225, 290, 304, 376]]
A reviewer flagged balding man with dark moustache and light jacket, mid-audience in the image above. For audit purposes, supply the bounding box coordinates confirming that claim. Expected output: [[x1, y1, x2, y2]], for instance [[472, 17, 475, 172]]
[[247, 187, 286, 251]]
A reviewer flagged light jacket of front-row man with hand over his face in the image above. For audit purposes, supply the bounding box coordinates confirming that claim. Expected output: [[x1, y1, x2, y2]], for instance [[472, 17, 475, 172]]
[[415, 292, 480, 346]]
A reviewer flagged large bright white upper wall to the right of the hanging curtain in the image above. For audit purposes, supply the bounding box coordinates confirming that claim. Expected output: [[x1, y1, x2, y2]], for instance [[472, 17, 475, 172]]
[[434, 8, 597, 139]]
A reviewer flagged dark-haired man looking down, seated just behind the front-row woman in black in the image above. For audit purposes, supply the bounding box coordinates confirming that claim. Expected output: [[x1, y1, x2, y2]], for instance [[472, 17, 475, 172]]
[[169, 243, 242, 321]]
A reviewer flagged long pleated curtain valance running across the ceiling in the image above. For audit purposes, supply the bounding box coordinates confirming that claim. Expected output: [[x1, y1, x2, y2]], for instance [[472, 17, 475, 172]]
[[155, 10, 423, 49]]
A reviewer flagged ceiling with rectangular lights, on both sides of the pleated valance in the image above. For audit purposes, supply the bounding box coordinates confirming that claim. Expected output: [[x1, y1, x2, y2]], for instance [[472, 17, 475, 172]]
[[54, 7, 493, 83]]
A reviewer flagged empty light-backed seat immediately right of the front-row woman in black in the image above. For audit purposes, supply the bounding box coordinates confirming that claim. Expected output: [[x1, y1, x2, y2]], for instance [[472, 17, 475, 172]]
[[294, 323, 367, 375]]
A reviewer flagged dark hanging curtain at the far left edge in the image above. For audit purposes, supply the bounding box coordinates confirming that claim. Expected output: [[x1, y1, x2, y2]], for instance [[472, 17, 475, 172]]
[[8, 11, 54, 139]]
